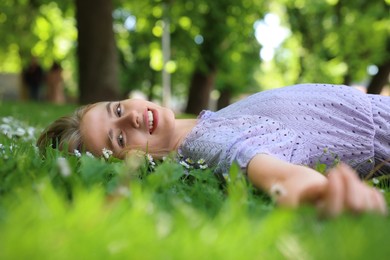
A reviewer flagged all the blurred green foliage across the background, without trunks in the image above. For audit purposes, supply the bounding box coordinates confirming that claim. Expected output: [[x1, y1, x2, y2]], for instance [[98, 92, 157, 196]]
[[0, 0, 390, 103]]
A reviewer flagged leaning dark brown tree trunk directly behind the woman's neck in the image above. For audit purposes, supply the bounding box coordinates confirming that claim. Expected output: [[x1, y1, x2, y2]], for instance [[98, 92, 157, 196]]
[[185, 70, 216, 115]]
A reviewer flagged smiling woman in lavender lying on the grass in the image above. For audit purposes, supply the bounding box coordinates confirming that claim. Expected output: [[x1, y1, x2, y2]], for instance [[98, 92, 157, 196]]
[[38, 84, 390, 215]]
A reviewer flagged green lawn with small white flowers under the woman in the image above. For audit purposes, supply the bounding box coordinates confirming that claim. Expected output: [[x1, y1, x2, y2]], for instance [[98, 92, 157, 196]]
[[0, 102, 390, 259]]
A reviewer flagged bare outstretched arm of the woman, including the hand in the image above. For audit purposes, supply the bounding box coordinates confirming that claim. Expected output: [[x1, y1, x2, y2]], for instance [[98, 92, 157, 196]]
[[248, 154, 386, 216]]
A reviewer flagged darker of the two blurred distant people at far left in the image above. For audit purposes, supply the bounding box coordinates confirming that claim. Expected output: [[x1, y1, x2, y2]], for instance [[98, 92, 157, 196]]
[[23, 57, 44, 101]]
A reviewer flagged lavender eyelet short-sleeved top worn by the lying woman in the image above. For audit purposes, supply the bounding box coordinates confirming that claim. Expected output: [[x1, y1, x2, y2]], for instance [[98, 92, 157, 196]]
[[179, 84, 390, 176]]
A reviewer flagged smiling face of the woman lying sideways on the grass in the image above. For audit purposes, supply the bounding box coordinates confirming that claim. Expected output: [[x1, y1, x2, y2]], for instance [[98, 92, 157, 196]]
[[80, 99, 175, 158]]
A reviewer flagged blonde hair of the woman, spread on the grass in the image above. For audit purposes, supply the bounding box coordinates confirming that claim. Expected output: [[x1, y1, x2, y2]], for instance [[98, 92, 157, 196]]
[[37, 104, 95, 154]]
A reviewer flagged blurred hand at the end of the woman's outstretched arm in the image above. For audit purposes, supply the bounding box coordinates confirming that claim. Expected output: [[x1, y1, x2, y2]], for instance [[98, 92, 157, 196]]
[[317, 164, 387, 216]]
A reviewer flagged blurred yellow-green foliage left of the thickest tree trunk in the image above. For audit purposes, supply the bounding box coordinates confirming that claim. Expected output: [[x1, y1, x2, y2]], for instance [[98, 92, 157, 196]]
[[0, 0, 77, 72]]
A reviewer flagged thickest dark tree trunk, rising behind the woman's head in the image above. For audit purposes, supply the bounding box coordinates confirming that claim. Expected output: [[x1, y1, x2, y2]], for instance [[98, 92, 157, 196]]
[[76, 0, 119, 104]]
